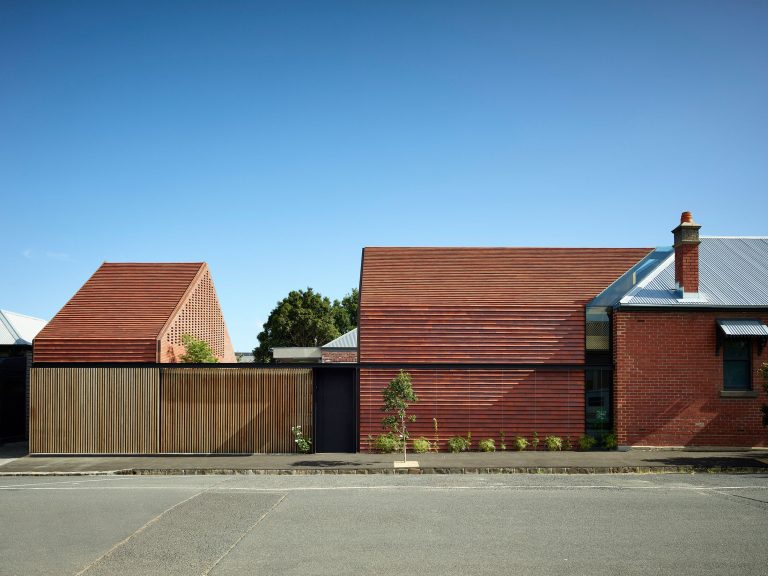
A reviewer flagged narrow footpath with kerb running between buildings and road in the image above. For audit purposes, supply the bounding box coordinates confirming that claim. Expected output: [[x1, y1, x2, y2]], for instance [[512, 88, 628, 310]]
[[0, 444, 768, 476]]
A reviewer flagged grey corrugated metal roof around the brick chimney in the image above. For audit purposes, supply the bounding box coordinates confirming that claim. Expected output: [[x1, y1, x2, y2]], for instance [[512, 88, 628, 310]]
[[621, 236, 768, 307]]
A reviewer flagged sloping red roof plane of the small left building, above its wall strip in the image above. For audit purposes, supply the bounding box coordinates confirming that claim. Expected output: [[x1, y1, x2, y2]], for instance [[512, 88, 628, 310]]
[[37, 262, 205, 339]]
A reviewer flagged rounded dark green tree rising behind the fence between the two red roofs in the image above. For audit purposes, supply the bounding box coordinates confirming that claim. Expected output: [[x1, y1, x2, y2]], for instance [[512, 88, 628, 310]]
[[253, 288, 341, 362]]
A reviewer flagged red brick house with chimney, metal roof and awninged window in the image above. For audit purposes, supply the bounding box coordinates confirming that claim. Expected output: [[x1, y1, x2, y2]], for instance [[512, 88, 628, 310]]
[[612, 213, 768, 446]]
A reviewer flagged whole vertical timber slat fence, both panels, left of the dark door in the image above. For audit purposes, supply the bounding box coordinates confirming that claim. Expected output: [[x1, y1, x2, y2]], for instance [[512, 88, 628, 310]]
[[29, 367, 313, 454]]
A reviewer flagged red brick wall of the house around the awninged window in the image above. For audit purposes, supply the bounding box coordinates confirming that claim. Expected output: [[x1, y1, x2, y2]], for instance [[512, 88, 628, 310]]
[[613, 309, 768, 446]]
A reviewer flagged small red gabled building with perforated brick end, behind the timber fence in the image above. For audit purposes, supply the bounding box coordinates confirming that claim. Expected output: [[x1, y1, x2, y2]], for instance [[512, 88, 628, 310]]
[[34, 262, 235, 363]]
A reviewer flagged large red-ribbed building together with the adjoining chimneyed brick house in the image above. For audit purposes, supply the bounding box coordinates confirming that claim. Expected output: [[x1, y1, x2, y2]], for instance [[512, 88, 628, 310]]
[[358, 213, 768, 450]]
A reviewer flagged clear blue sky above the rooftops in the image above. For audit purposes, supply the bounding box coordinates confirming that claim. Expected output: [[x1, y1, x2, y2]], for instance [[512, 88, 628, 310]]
[[0, 0, 768, 350]]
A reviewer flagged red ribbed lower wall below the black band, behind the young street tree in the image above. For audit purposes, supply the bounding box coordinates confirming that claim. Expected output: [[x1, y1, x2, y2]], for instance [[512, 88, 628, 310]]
[[360, 368, 584, 451]]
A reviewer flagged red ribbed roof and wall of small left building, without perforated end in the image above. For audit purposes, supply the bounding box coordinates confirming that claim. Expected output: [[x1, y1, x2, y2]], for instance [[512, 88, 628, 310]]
[[34, 262, 204, 362]]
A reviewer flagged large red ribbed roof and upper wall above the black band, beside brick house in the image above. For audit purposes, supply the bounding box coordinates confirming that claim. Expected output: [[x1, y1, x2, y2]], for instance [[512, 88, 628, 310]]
[[358, 248, 650, 364]]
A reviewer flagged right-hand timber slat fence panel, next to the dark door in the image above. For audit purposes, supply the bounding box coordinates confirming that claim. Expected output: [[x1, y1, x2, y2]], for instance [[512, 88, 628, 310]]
[[160, 368, 312, 453]]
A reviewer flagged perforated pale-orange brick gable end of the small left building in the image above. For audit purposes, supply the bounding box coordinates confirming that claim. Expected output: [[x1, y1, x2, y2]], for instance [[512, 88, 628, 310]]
[[160, 265, 237, 363]]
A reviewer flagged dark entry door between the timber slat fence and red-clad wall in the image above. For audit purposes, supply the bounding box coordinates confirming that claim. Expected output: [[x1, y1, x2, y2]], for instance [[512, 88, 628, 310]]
[[315, 368, 357, 452]]
